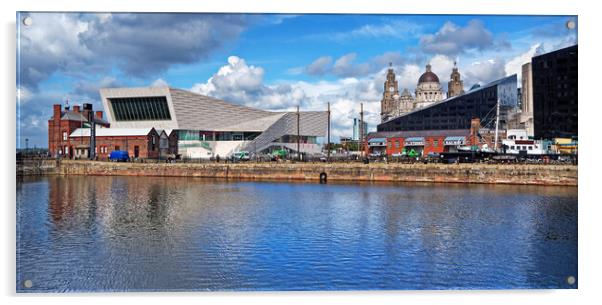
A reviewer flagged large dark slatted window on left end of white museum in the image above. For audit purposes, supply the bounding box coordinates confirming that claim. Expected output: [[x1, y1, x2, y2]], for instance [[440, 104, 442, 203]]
[[109, 96, 171, 121]]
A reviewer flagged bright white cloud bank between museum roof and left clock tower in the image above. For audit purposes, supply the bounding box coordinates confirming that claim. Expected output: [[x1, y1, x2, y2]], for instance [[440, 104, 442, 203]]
[[191, 56, 383, 137]]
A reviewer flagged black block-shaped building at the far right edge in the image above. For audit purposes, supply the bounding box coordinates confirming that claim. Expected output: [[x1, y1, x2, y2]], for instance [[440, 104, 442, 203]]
[[531, 45, 578, 139]]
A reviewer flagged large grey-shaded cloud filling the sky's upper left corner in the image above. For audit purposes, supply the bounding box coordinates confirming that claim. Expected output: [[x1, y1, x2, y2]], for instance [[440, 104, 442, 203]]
[[17, 12, 248, 90]]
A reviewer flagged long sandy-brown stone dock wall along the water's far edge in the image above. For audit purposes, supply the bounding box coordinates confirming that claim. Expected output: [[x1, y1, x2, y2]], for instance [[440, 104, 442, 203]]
[[55, 160, 578, 186]]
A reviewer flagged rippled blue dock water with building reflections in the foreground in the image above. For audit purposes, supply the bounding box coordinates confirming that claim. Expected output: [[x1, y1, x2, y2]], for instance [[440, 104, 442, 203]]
[[17, 177, 577, 291]]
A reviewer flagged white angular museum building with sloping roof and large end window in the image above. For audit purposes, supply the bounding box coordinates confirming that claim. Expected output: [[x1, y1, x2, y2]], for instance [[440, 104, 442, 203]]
[[100, 87, 328, 158]]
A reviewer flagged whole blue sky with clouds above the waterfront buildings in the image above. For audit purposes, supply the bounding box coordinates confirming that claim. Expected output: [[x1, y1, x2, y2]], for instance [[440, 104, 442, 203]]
[[17, 13, 577, 147]]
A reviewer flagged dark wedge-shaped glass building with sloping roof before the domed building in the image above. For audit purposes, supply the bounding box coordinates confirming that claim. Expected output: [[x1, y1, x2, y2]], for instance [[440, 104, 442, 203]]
[[377, 74, 518, 132]]
